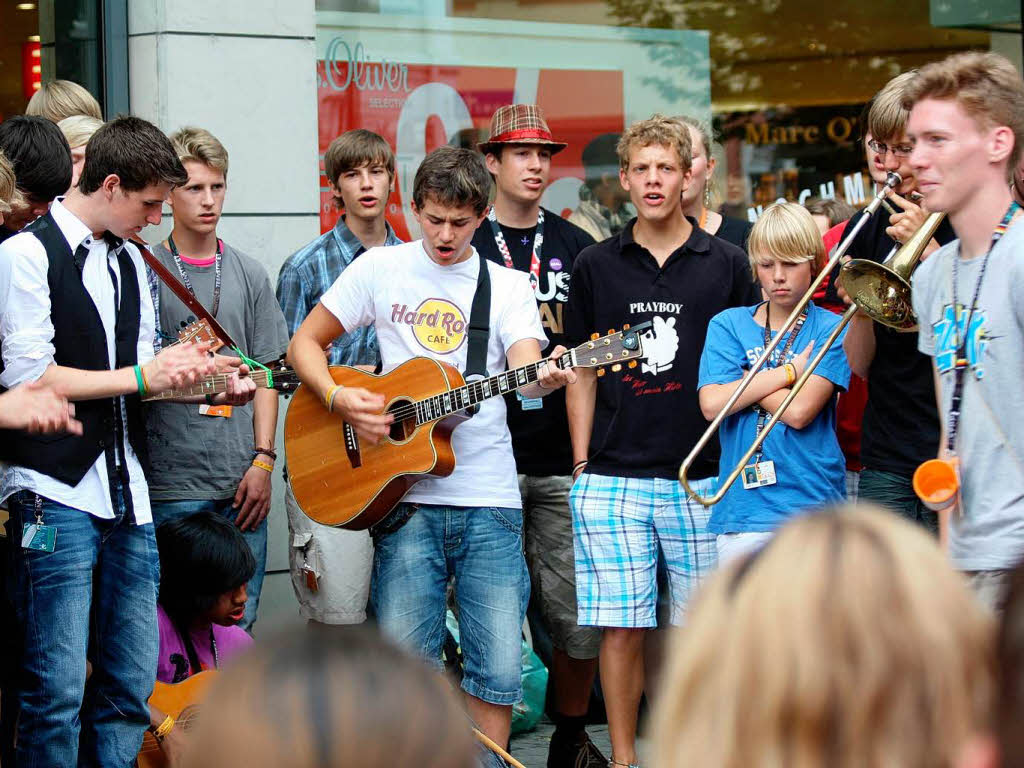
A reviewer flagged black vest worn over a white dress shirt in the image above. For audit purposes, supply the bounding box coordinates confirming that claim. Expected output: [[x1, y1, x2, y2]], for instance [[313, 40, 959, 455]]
[[0, 214, 147, 485]]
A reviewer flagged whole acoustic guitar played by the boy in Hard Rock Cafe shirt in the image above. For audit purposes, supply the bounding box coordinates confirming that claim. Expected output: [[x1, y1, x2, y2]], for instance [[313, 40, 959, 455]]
[[285, 323, 651, 530]]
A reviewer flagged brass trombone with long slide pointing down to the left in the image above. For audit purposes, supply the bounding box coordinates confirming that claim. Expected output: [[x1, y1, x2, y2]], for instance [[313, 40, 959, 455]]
[[679, 172, 943, 507]]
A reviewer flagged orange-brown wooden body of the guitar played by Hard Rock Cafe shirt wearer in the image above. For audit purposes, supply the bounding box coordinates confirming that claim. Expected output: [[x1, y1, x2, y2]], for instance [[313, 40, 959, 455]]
[[285, 357, 469, 530]]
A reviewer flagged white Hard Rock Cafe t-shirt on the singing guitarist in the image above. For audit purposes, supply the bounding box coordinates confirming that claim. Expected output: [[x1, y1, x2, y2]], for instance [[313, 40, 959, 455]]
[[321, 241, 548, 509]]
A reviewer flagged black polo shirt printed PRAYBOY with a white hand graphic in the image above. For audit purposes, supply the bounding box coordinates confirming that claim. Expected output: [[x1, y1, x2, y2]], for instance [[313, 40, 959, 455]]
[[565, 217, 761, 479]]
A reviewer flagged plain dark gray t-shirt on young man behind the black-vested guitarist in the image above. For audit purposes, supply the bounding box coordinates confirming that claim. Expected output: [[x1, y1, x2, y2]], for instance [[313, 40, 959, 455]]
[[146, 243, 288, 501]]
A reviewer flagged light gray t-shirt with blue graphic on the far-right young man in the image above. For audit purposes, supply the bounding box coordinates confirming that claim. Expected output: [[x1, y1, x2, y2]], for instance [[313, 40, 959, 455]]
[[912, 219, 1024, 570]]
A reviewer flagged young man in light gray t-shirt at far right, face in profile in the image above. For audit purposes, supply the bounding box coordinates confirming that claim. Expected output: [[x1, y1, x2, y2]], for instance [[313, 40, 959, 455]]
[[903, 52, 1024, 606]]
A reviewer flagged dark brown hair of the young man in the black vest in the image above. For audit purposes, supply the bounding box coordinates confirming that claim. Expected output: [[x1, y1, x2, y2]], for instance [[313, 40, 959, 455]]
[[78, 116, 188, 195]]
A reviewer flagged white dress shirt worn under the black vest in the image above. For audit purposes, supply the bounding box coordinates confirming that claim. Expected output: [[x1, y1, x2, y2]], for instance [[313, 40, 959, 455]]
[[0, 200, 156, 524]]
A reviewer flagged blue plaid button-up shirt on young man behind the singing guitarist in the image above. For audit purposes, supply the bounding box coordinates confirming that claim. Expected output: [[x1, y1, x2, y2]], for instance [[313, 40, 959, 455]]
[[278, 218, 401, 366]]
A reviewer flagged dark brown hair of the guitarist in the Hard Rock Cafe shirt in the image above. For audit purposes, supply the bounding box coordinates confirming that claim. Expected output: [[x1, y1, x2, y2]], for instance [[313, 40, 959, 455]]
[[413, 146, 490, 216]]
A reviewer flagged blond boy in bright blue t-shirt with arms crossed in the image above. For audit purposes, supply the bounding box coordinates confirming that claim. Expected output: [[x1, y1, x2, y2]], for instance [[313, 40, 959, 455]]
[[697, 203, 850, 564]]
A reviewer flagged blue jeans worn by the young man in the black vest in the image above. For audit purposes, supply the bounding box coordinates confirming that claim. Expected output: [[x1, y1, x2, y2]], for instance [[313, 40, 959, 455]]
[[9, 492, 160, 768]]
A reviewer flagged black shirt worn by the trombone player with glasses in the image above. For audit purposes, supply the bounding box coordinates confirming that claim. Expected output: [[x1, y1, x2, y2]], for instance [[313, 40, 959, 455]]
[[825, 207, 956, 477]]
